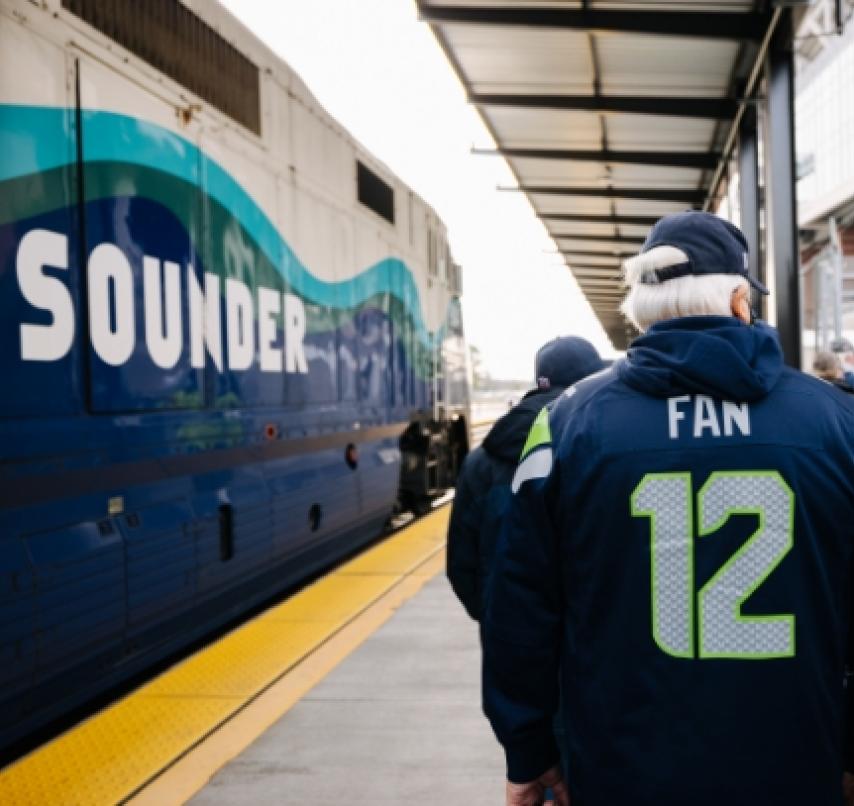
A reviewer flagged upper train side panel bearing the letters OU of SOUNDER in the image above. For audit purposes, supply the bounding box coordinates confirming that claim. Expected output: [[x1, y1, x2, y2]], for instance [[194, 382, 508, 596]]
[[78, 58, 205, 416]]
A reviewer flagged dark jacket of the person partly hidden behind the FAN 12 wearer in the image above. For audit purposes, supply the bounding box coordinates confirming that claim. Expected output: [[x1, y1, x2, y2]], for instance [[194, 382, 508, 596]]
[[447, 389, 563, 621]]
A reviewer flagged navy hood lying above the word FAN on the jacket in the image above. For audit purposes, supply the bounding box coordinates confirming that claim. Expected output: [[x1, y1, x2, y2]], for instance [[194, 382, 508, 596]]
[[619, 316, 783, 402]]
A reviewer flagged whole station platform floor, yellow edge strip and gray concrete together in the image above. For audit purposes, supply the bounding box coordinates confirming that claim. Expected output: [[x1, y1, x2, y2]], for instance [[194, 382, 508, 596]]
[[0, 506, 504, 806]]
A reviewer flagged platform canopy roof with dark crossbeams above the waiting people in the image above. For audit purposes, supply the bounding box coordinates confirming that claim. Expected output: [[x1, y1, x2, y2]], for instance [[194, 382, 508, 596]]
[[418, 0, 777, 349]]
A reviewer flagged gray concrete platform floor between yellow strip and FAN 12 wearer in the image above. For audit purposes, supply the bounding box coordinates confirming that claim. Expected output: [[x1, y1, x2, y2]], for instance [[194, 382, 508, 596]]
[[190, 575, 504, 806]]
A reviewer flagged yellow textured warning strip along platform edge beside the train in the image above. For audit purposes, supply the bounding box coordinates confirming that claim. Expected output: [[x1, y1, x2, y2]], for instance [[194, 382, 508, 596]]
[[0, 507, 449, 806]]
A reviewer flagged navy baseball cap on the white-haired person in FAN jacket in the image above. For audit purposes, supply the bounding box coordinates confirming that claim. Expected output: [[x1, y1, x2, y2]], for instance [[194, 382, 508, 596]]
[[641, 210, 768, 294]]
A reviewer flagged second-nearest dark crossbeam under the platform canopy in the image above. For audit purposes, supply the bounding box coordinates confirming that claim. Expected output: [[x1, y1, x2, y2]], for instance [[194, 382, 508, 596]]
[[469, 92, 738, 120]]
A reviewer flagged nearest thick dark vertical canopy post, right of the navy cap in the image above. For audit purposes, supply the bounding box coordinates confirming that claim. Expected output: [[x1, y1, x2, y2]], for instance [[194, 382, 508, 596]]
[[765, 10, 801, 367]]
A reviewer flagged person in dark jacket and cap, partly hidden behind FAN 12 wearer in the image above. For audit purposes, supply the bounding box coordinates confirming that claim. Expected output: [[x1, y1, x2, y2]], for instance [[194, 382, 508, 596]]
[[447, 336, 605, 621]]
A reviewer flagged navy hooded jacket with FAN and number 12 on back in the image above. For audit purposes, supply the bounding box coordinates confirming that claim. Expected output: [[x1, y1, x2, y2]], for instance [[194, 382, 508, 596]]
[[482, 317, 854, 806]]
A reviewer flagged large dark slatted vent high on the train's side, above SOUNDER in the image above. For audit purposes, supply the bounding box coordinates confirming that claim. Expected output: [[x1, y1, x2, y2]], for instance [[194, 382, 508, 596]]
[[62, 0, 261, 134]]
